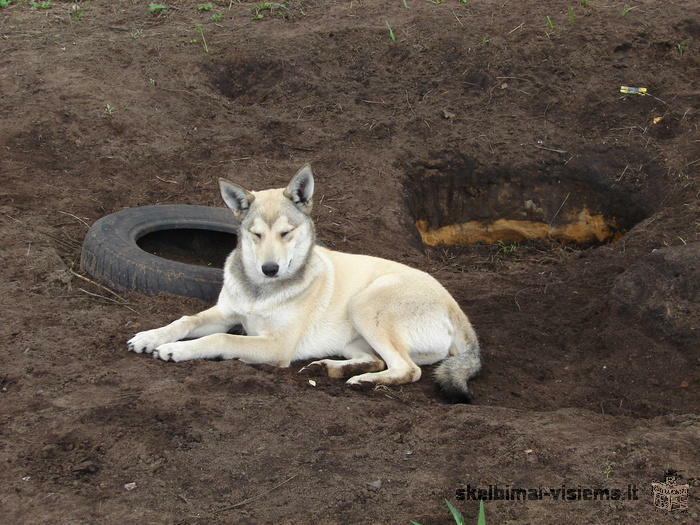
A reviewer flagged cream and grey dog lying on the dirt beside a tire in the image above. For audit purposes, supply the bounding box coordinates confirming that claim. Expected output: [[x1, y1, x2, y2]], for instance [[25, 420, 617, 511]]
[[127, 164, 481, 401]]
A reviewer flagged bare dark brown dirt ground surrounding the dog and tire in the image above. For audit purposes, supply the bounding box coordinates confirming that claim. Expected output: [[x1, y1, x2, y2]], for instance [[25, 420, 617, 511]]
[[0, 0, 700, 525]]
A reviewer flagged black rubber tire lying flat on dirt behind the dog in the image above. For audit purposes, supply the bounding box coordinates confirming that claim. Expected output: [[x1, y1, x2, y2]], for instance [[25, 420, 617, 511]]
[[80, 205, 238, 302]]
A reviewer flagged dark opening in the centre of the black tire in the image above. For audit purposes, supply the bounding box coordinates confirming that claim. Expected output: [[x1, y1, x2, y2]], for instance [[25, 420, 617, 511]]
[[136, 229, 236, 268]]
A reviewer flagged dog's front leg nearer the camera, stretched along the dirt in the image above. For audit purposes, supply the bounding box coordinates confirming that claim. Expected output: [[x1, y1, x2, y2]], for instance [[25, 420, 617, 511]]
[[153, 334, 294, 367]]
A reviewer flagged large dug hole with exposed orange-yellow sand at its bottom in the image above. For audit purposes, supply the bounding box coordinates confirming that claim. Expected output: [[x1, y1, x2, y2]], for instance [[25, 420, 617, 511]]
[[406, 154, 646, 246]]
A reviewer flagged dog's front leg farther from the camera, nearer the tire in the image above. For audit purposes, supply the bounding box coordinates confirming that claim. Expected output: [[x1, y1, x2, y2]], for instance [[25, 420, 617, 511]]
[[127, 306, 238, 354]]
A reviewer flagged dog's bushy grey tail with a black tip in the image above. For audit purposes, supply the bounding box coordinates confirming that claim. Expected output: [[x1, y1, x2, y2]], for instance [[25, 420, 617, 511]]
[[434, 311, 481, 403]]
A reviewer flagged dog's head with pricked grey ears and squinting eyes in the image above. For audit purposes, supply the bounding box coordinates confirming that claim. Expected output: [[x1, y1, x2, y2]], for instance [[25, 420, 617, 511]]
[[219, 164, 315, 284]]
